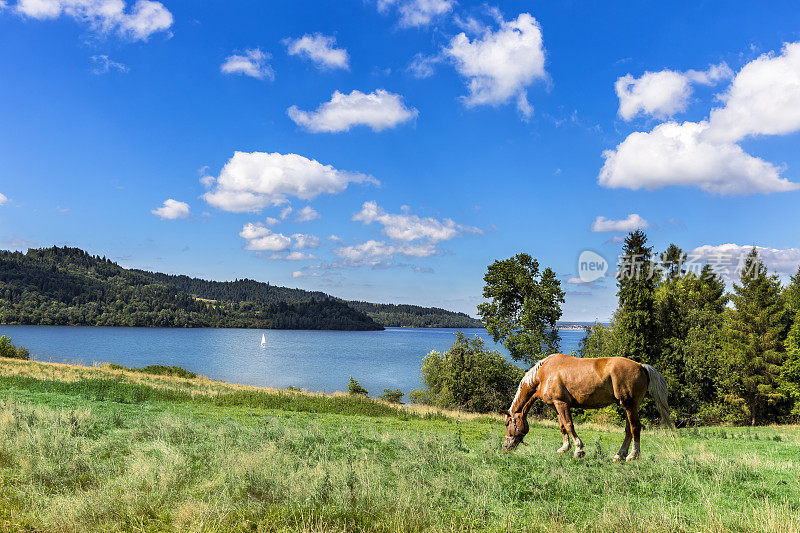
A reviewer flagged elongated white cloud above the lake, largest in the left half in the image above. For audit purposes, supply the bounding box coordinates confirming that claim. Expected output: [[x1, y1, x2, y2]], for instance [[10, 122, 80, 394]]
[[203, 152, 377, 212]]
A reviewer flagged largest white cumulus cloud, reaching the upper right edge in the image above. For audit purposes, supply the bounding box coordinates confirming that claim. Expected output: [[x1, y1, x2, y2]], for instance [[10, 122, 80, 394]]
[[598, 43, 800, 194]]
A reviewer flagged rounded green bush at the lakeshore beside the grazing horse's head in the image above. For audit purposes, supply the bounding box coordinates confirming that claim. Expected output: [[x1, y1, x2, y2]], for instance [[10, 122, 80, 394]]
[[410, 332, 525, 413]]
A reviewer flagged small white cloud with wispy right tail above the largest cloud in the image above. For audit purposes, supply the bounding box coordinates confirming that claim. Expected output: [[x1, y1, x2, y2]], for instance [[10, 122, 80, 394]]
[[614, 63, 733, 120]]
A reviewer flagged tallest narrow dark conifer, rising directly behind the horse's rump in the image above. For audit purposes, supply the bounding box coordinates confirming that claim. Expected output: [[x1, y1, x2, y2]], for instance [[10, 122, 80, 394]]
[[617, 230, 659, 364]]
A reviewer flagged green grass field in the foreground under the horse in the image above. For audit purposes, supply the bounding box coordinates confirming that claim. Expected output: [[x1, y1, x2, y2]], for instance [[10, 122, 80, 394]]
[[0, 360, 800, 533]]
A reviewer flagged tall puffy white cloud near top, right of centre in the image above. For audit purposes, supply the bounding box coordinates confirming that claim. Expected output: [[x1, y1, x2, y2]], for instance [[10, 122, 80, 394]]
[[444, 13, 547, 117]]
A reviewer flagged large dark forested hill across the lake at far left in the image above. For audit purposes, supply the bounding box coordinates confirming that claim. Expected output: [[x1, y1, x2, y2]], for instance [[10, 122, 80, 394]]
[[0, 247, 382, 330]]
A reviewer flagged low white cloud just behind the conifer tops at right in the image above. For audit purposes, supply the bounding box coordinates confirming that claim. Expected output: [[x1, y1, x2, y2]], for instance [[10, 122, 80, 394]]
[[688, 243, 800, 279]]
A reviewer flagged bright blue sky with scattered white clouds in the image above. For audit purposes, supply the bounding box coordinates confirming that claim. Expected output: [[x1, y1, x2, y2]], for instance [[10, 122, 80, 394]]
[[0, 0, 800, 321]]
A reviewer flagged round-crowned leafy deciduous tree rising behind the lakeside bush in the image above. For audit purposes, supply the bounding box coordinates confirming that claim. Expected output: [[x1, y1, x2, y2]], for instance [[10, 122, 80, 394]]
[[478, 253, 564, 365]]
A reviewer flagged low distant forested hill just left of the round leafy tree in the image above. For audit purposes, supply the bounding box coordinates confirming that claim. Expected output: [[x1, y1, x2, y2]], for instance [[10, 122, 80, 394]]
[[348, 302, 483, 328]]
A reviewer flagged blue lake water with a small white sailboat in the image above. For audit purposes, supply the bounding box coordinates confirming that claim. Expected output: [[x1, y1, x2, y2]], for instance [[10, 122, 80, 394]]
[[0, 326, 584, 395]]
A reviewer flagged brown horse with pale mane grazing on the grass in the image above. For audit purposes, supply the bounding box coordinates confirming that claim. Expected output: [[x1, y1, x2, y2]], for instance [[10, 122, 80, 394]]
[[503, 353, 674, 461]]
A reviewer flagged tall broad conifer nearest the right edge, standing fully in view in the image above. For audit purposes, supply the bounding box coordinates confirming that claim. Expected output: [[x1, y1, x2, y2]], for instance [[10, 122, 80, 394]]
[[723, 248, 786, 425]]
